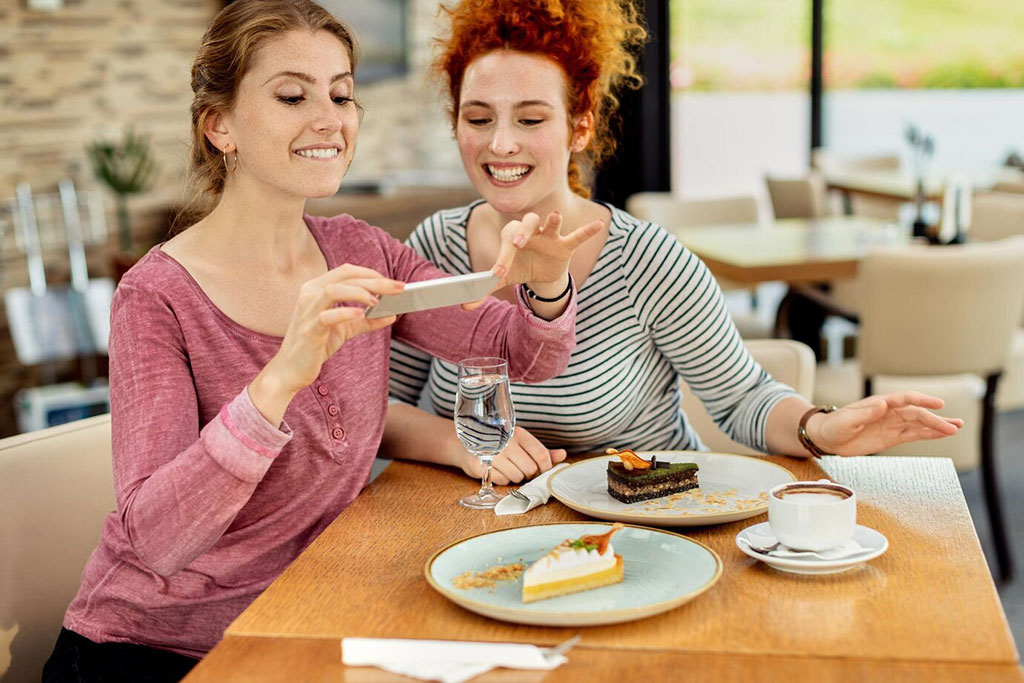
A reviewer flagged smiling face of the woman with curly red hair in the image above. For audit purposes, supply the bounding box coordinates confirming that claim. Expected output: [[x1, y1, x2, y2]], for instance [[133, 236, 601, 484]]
[[456, 50, 591, 222]]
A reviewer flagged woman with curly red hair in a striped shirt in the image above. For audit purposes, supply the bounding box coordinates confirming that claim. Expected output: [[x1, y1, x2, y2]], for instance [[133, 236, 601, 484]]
[[383, 0, 961, 491]]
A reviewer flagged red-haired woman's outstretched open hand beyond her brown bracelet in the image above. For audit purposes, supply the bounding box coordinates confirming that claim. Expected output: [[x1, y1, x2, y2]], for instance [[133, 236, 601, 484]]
[[807, 391, 964, 456]]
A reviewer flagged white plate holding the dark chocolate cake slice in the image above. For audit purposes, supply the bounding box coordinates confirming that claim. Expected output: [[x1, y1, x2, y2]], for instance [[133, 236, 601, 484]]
[[548, 451, 797, 526]]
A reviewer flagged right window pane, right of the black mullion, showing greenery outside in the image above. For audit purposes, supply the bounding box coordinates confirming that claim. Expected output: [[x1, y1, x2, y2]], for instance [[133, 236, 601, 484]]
[[823, 0, 1024, 181]]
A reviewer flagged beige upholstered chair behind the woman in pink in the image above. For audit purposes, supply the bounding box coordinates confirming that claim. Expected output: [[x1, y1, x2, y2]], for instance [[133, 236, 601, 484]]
[[0, 415, 115, 681]]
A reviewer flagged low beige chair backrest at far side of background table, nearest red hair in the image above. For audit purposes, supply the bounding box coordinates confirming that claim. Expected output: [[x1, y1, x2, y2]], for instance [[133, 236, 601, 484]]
[[626, 193, 758, 228]]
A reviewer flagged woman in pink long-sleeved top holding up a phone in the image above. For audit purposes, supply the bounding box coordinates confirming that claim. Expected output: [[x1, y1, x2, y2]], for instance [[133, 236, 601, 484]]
[[44, 0, 599, 681]]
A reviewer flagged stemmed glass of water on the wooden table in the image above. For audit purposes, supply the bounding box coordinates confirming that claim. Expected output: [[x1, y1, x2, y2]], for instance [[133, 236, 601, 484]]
[[455, 357, 515, 510]]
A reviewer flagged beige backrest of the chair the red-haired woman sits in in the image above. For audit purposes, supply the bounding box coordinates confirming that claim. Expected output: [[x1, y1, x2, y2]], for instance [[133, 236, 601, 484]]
[[681, 339, 815, 455]]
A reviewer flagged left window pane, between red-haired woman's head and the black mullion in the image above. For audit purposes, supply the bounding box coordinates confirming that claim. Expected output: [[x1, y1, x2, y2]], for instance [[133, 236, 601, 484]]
[[671, 0, 811, 198]]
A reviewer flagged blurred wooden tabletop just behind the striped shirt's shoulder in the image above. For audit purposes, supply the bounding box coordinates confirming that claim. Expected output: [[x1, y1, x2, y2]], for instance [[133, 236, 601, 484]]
[[668, 216, 910, 285]]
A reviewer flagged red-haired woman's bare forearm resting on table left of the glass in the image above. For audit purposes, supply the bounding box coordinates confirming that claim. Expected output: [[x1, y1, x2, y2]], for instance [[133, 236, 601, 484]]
[[380, 403, 466, 467]]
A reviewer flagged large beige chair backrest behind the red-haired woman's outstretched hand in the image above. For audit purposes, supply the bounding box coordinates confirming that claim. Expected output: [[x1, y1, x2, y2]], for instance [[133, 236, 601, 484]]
[[858, 237, 1024, 377]]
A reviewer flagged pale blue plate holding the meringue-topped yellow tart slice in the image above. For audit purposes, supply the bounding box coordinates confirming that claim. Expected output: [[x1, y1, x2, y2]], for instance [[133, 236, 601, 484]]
[[424, 522, 722, 626]]
